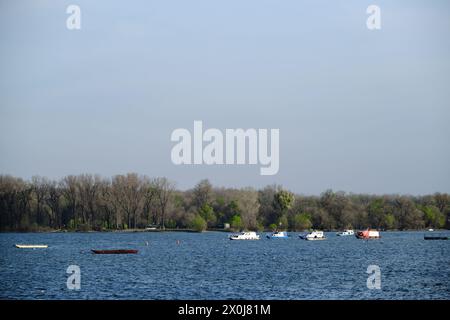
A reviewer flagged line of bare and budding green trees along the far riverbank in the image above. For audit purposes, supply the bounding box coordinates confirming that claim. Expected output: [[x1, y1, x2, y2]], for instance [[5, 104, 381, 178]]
[[0, 173, 450, 231]]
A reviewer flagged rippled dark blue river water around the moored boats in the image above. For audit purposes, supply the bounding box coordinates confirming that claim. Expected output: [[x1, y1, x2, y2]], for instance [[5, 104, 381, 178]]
[[0, 232, 450, 299]]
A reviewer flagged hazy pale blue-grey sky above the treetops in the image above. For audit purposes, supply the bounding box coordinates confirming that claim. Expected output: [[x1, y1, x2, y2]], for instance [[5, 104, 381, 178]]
[[0, 0, 450, 195]]
